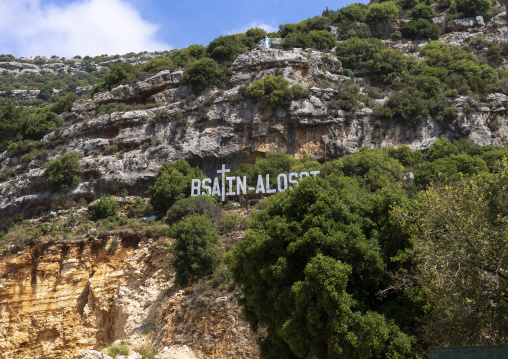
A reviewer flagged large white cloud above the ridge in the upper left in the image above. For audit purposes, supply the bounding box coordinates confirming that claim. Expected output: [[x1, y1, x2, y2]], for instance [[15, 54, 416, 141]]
[[0, 0, 170, 57]]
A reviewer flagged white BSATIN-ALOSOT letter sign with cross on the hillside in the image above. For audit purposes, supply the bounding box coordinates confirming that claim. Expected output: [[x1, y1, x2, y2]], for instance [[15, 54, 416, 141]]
[[191, 165, 320, 201]]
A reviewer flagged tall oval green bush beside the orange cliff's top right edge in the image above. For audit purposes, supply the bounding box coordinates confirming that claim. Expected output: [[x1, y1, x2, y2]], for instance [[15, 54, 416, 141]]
[[171, 214, 219, 287]]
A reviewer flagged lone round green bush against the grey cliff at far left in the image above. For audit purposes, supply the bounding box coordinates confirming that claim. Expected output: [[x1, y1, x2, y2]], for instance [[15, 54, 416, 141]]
[[43, 153, 81, 192]]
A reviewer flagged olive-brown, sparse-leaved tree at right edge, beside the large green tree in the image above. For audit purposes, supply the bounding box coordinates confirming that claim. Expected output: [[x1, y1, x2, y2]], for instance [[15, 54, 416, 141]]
[[406, 165, 508, 346]]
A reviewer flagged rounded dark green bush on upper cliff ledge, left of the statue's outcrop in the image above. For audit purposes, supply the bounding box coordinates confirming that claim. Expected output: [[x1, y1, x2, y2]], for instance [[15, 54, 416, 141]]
[[183, 58, 224, 90]]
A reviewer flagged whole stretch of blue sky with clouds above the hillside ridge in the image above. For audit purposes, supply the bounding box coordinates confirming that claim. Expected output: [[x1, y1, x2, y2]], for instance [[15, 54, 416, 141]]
[[0, 0, 366, 57]]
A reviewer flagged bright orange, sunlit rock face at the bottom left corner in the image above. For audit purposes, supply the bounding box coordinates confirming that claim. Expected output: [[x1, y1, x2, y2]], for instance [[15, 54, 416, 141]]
[[0, 235, 140, 359]]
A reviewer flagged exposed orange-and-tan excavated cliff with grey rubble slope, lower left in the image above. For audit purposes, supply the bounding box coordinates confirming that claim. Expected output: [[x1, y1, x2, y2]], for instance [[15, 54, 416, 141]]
[[0, 231, 258, 359]]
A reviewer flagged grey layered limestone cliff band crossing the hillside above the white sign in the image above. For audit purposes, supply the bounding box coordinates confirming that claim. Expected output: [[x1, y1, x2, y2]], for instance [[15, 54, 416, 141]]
[[0, 14, 508, 222]]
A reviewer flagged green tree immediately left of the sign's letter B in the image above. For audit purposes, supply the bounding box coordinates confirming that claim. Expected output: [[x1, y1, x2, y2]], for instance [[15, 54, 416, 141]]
[[146, 158, 205, 213]]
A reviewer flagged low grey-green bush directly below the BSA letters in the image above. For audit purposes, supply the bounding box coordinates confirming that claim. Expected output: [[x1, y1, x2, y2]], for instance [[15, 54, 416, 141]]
[[165, 195, 220, 224]]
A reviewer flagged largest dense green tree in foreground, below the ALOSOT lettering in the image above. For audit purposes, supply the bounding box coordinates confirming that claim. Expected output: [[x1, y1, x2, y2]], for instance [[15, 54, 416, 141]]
[[227, 176, 411, 358]]
